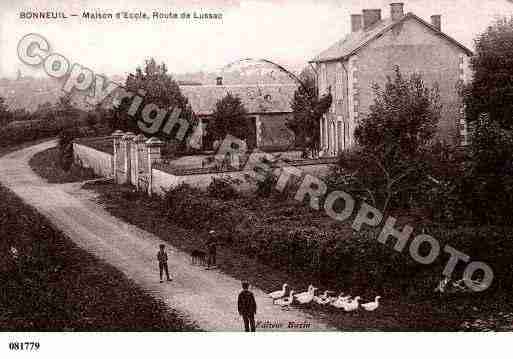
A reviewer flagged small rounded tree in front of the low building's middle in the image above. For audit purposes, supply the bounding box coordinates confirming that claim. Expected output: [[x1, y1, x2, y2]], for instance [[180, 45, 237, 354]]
[[208, 93, 251, 146]]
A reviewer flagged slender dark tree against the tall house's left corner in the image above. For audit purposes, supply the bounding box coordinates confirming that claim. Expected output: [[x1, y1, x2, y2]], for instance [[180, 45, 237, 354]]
[[287, 70, 333, 152]]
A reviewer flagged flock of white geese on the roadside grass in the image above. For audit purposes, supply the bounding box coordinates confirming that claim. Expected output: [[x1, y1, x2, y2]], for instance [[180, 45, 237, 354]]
[[269, 283, 381, 312]]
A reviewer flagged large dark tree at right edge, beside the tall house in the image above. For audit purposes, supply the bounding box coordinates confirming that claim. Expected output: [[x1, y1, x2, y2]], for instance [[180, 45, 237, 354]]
[[456, 17, 513, 223]]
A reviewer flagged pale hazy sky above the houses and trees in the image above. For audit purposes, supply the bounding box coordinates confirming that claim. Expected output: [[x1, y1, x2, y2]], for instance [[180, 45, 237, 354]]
[[0, 0, 513, 77]]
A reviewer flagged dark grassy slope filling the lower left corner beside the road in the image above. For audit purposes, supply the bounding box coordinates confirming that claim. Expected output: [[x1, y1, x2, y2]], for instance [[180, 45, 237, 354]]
[[0, 186, 196, 331]]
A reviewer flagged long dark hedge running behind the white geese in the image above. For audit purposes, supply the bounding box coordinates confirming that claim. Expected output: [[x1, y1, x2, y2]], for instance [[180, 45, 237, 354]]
[[162, 185, 513, 295]]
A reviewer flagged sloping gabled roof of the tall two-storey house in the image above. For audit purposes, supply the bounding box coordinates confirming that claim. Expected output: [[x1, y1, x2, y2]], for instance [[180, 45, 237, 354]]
[[310, 12, 472, 62]]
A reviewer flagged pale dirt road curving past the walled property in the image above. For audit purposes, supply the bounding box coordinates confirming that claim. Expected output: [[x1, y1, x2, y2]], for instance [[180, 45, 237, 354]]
[[0, 141, 329, 331]]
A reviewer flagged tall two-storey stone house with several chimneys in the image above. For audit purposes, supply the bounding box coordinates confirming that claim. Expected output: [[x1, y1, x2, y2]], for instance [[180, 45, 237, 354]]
[[310, 3, 472, 155]]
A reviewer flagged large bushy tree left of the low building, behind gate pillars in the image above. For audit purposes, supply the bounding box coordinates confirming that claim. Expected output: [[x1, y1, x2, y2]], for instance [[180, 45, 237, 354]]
[[116, 58, 194, 147]]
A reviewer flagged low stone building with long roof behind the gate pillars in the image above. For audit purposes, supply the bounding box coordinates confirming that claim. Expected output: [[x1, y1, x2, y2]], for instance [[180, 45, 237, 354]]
[[180, 78, 297, 150]]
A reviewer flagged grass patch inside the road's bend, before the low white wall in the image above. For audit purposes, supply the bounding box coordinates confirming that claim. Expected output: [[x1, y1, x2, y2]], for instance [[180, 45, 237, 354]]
[[29, 147, 98, 183]]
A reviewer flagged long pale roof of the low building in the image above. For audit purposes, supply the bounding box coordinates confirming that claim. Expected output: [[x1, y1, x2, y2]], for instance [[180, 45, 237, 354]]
[[180, 84, 298, 115]]
